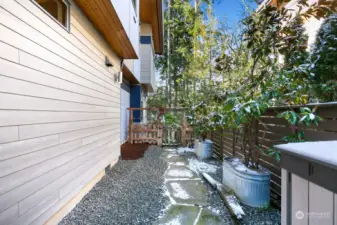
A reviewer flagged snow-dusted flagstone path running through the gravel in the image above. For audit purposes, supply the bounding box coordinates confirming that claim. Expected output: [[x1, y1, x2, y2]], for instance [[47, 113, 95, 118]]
[[154, 149, 223, 225]]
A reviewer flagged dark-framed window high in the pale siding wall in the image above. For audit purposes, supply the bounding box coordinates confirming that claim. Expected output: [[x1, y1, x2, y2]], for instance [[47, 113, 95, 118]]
[[33, 0, 70, 29]]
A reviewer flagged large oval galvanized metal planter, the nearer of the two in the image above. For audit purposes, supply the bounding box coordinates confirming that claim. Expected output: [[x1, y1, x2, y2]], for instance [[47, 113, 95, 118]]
[[223, 158, 271, 208]]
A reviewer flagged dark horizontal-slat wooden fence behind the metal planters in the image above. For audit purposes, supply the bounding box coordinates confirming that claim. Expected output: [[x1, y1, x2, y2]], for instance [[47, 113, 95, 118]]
[[210, 103, 337, 205]]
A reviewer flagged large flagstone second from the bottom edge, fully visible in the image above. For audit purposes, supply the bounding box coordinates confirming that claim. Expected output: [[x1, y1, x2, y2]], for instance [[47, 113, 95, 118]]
[[165, 180, 208, 206]]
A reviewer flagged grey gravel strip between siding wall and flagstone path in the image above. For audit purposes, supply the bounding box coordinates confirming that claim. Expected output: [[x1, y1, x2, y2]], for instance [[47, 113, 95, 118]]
[[60, 146, 167, 225]]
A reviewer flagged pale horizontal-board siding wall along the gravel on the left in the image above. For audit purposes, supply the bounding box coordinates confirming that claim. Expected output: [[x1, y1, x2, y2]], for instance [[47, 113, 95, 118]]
[[0, 0, 120, 225]]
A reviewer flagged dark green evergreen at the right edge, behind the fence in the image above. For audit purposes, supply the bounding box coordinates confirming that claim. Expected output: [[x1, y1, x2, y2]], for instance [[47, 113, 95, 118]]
[[311, 14, 337, 101]]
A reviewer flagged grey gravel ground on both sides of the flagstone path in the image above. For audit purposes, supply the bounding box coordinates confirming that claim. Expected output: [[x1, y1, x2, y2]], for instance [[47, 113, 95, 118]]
[[60, 146, 281, 225]]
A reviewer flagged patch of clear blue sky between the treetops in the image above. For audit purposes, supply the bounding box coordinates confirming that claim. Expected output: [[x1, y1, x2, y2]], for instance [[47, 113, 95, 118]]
[[213, 0, 257, 28]]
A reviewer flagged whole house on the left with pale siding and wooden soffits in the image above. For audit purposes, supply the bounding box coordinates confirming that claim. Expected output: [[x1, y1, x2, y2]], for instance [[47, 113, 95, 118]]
[[0, 0, 163, 225]]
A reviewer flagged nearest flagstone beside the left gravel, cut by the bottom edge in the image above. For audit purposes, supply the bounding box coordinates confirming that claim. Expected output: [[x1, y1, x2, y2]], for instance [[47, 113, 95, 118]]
[[154, 205, 200, 225]]
